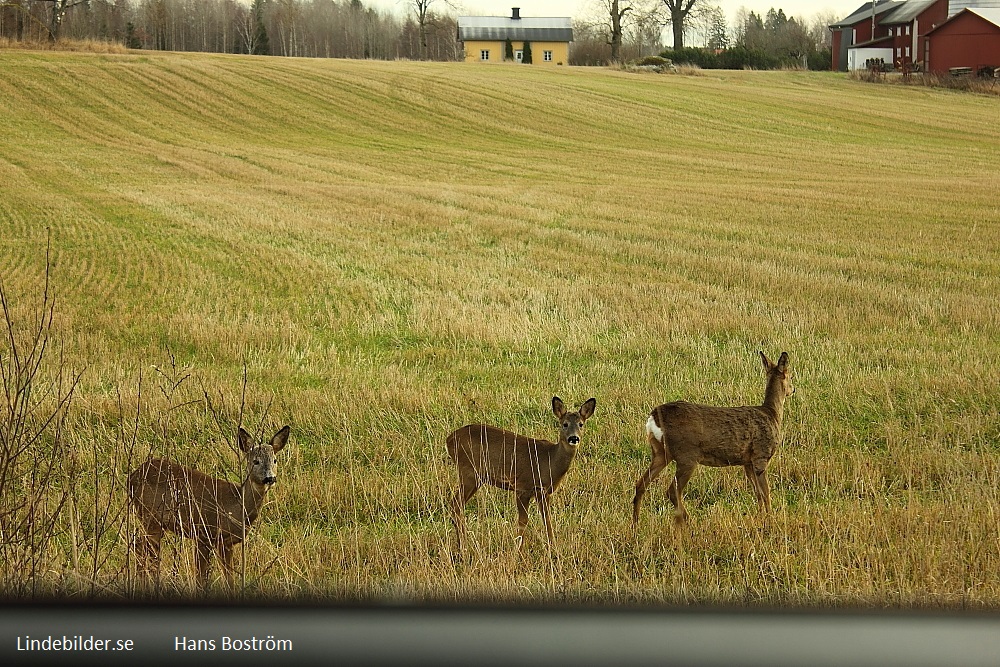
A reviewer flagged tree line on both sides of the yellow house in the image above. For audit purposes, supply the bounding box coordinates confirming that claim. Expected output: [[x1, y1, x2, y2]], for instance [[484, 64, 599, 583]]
[[0, 0, 836, 69]]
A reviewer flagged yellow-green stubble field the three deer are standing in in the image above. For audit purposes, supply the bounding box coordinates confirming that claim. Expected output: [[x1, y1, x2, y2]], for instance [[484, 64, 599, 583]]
[[0, 51, 1000, 607]]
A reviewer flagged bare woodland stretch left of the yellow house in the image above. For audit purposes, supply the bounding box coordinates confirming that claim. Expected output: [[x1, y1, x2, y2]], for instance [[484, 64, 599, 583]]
[[0, 0, 462, 60]]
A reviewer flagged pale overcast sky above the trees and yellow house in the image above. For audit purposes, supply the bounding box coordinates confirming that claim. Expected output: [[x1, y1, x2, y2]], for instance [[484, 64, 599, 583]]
[[410, 0, 864, 21]]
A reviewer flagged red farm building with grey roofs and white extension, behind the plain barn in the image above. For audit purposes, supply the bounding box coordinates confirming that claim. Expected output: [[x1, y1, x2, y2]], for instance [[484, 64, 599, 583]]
[[830, 0, 1000, 71]]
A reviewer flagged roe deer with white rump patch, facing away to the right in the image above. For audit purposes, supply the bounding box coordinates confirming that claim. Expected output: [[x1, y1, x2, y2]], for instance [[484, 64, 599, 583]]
[[632, 352, 795, 524]]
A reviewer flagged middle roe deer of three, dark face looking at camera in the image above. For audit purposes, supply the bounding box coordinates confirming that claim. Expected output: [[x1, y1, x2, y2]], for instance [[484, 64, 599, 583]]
[[448, 396, 597, 554]]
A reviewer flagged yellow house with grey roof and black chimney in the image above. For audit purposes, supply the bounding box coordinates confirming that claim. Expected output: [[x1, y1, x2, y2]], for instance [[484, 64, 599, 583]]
[[458, 7, 573, 65]]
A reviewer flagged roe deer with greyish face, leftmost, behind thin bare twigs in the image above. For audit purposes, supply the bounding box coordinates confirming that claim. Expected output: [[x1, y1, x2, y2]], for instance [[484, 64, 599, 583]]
[[128, 426, 289, 589]]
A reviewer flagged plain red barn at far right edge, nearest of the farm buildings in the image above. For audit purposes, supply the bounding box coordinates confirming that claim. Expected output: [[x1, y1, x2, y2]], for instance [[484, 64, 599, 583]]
[[924, 9, 1000, 73]]
